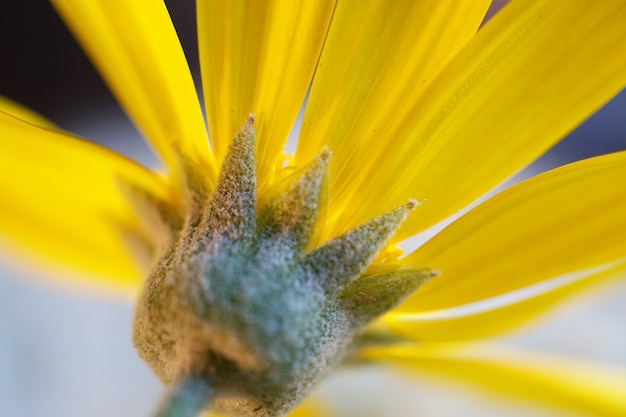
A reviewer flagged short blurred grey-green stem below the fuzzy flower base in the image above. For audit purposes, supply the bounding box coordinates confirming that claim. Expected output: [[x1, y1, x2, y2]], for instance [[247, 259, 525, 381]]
[[155, 375, 213, 417]]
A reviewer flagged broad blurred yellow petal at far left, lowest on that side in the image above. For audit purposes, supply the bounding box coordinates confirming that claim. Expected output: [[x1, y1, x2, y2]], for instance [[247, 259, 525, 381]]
[[0, 113, 169, 291]]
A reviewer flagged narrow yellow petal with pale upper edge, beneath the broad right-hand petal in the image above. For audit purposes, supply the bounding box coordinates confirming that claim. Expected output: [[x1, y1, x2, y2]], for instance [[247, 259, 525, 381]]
[[370, 262, 626, 341]]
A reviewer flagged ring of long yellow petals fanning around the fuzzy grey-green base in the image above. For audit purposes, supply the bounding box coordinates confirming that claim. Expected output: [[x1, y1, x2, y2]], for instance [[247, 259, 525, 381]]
[[0, 0, 626, 416]]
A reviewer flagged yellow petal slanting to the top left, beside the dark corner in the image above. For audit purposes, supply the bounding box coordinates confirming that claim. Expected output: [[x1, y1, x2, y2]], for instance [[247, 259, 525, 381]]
[[52, 0, 216, 182]]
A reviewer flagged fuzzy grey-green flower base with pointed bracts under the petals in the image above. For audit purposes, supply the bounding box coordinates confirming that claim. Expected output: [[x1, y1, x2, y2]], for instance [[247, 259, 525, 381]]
[[133, 118, 429, 417]]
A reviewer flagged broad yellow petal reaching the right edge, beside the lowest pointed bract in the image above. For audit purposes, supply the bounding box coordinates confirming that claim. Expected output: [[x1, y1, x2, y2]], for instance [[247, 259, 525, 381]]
[[401, 152, 626, 312]]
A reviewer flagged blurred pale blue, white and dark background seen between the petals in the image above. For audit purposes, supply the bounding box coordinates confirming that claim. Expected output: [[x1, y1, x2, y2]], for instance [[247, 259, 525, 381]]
[[0, 0, 626, 417]]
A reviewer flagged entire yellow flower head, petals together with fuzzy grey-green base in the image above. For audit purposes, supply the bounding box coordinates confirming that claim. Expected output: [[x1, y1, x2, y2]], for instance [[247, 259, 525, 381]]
[[0, 0, 626, 416]]
